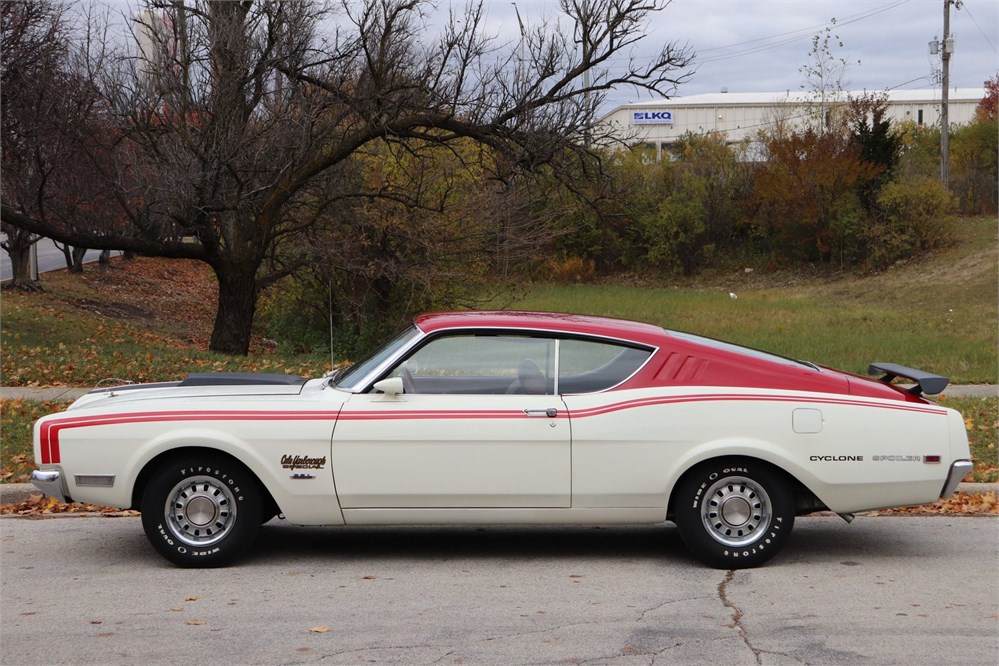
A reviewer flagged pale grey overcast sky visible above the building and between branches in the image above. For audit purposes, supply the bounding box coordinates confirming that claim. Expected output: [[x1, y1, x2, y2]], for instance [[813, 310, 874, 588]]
[[92, 0, 999, 112]]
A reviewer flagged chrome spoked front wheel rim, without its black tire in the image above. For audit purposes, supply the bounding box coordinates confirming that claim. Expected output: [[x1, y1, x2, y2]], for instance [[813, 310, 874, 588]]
[[163, 476, 236, 547]]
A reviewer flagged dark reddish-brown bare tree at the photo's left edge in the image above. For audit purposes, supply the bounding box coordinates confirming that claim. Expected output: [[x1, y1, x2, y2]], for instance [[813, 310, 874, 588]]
[[0, 1, 135, 288]]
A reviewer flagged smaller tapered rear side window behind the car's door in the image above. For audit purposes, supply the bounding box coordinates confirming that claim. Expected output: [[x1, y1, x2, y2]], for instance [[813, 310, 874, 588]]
[[558, 340, 652, 393]]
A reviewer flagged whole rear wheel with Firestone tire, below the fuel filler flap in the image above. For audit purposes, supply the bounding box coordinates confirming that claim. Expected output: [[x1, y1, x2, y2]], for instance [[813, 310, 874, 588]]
[[673, 458, 795, 569]]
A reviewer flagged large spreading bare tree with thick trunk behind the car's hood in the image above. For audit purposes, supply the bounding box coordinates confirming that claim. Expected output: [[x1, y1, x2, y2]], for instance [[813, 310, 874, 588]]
[[2, 0, 689, 353]]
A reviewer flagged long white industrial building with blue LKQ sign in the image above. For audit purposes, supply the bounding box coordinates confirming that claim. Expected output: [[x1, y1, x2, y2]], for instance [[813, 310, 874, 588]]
[[601, 88, 985, 153]]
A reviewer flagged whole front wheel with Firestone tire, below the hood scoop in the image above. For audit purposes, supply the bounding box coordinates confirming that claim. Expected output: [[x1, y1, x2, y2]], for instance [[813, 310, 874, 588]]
[[140, 455, 263, 568]]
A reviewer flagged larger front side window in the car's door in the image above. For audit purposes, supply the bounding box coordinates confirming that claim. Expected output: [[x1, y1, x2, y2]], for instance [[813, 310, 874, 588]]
[[389, 335, 555, 395]]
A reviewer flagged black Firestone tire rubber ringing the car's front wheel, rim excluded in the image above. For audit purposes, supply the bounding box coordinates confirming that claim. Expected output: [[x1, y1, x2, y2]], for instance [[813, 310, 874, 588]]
[[140, 455, 263, 568]]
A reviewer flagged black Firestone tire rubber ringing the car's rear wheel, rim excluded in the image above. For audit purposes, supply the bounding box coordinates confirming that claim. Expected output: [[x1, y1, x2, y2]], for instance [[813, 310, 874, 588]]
[[673, 458, 795, 569]]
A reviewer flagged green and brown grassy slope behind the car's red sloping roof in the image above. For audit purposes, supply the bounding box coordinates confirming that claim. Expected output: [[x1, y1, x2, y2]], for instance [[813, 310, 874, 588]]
[[512, 218, 999, 384]]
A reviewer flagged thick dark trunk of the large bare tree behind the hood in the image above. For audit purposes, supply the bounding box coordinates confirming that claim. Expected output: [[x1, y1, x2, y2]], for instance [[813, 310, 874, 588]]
[[208, 265, 257, 356]]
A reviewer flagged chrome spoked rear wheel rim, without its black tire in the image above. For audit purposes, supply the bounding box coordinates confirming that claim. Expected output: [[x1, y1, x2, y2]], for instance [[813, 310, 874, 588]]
[[701, 476, 771, 548]]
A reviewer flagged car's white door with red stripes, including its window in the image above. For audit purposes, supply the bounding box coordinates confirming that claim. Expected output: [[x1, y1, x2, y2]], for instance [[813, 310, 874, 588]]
[[332, 333, 572, 509]]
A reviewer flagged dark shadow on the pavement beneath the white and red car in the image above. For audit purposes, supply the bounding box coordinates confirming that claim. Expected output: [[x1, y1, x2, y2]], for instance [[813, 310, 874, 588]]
[[248, 516, 941, 568]]
